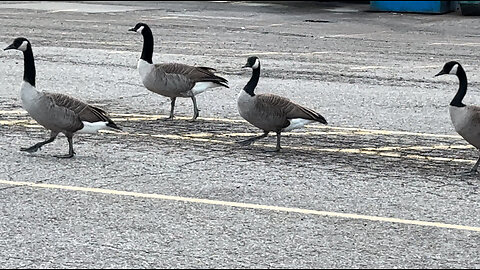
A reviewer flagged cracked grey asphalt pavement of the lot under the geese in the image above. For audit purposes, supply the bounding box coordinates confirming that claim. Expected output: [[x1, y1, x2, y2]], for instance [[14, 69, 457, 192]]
[[0, 1, 480, 269]]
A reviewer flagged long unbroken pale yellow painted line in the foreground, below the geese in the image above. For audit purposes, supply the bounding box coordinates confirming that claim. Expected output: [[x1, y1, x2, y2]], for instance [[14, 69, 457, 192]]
[[0, 180, 480, 232]]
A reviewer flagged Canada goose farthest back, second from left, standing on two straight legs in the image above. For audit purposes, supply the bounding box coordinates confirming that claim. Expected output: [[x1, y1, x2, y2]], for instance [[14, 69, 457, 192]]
[[129, 23, 228, 120]]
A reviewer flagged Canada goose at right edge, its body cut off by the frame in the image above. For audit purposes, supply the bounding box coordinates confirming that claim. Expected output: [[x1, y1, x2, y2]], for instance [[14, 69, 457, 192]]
[[435, 61, 480, 173]]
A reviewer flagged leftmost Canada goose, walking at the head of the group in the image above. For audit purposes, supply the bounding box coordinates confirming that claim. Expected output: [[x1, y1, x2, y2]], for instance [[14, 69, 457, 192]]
[[4, 37, 120, 158]]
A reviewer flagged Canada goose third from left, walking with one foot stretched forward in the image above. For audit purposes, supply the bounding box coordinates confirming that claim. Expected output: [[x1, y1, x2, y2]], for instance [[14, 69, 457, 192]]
[[237, 56, 327, 152]]
